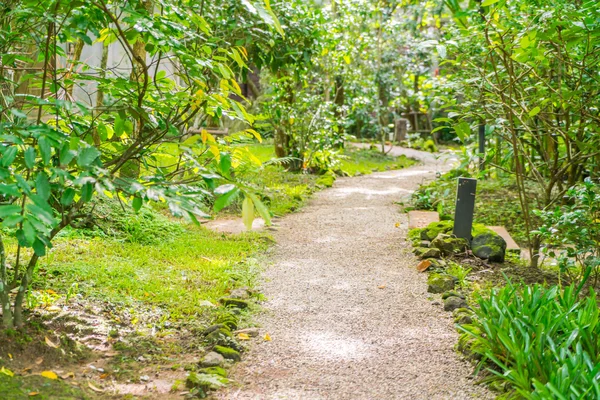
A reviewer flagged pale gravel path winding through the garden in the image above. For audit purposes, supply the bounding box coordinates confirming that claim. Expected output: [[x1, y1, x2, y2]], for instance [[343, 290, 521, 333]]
[[217, 148, 491, 400]]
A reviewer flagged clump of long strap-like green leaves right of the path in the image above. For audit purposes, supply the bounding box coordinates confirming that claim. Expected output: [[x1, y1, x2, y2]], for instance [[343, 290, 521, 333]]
[[460, 284, 600, 399]]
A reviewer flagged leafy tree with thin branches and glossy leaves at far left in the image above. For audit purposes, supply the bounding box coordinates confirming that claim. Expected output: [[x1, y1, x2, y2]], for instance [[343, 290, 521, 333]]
[[0, 0, 278, 328]]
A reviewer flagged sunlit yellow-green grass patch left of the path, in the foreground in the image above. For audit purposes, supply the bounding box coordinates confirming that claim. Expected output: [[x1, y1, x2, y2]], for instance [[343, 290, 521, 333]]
[[34, 225, 267, 320]]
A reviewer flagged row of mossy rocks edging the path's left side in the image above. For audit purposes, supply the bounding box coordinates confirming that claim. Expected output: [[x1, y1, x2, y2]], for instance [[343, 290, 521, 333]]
[[186, 288, 259, 398]]
